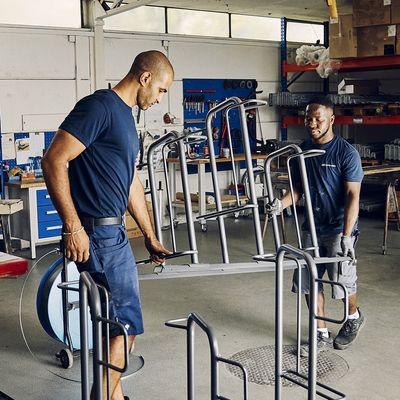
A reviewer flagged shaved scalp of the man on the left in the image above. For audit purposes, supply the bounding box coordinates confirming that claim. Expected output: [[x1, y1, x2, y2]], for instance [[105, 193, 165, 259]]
[[129, 50, 174, 78]]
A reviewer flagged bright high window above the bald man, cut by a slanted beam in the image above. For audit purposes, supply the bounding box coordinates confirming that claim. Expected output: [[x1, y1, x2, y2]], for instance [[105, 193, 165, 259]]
[[104, 2, 165, 33]]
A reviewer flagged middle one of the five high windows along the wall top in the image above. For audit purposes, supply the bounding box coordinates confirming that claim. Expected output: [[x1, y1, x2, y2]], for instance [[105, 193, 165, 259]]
[[167, 8, 229, 37]]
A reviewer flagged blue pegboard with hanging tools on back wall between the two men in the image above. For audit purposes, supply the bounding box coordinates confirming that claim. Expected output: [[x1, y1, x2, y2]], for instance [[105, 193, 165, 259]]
[[183, 79, 257, 172]]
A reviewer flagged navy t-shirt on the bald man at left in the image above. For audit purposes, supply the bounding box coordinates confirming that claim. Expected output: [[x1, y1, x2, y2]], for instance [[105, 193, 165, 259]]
[[60, 89, 139, 218]]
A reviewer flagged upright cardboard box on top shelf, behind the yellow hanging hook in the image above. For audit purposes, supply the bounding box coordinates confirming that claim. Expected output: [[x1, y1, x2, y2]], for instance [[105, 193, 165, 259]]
[[329, 15, 357, 58]]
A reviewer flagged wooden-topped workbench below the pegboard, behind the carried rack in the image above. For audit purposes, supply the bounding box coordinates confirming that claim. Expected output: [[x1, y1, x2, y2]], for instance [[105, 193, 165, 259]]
[[167, 154, 268, 231]]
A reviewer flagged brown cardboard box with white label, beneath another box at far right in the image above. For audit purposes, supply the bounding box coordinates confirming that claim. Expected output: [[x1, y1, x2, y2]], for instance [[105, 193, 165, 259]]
[[357, 25, 397, 57]]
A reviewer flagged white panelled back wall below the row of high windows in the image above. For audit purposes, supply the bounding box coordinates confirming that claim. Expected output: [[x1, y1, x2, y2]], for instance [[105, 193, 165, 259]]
[[0, 27, 286, 219]]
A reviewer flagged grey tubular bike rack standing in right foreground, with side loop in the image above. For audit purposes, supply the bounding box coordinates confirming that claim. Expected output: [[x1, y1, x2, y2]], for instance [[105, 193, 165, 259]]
[[275, 244, 348, 400]]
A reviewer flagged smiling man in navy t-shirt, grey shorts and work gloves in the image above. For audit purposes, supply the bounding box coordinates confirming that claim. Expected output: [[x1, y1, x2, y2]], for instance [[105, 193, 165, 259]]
[[276, 98, 365, 356]]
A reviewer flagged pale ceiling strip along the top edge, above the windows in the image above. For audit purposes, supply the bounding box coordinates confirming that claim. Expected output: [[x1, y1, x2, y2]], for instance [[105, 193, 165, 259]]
[[149, 0, 351, 21]]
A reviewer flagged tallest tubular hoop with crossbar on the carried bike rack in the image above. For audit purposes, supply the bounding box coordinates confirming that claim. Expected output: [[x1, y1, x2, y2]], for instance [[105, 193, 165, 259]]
[[197, 97, 267, 263]]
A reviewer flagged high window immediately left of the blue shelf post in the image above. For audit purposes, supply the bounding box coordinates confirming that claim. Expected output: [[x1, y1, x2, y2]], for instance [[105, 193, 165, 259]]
[[231, 14, 281, 40]]
